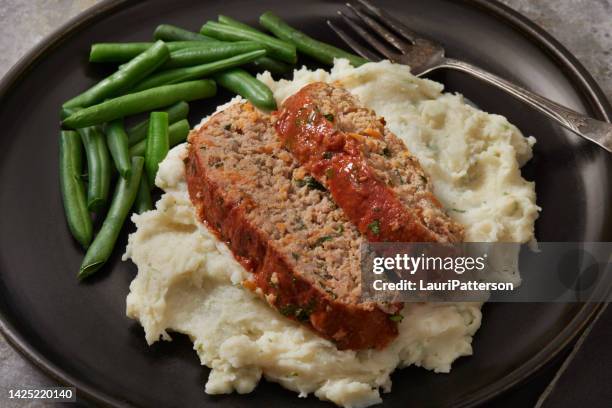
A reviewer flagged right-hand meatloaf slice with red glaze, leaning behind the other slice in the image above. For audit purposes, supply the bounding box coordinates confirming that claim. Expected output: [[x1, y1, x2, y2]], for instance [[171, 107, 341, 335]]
[[275, 82, 463, 242]]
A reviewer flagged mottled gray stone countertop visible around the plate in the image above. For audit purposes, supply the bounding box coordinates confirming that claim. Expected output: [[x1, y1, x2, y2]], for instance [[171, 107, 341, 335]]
[[0, 0, 612, 408]]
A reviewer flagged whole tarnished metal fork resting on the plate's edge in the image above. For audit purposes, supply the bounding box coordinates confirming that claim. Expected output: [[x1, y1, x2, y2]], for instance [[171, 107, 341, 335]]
[[327, 0, 612, 153]]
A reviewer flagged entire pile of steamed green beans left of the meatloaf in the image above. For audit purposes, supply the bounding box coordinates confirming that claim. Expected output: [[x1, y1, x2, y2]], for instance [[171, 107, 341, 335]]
[[59, 12, 367, 279]]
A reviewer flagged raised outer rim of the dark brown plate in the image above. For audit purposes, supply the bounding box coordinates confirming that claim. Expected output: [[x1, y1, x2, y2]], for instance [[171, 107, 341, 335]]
[[0, 0, 612, 408]]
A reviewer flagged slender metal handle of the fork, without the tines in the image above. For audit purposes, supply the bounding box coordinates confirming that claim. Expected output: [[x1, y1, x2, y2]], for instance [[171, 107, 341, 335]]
[[438, 58, 612, 153]]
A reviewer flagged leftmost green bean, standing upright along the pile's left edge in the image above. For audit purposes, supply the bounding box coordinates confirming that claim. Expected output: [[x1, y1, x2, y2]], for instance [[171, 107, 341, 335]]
[[59, 130, 93, 249]]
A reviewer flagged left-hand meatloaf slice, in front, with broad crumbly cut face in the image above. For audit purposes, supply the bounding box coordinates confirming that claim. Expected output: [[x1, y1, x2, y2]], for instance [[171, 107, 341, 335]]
[[186, 103, 401, 349]]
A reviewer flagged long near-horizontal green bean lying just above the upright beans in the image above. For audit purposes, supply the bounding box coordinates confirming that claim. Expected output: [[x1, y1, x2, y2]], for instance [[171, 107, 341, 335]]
[[62, 79, 217, 128]]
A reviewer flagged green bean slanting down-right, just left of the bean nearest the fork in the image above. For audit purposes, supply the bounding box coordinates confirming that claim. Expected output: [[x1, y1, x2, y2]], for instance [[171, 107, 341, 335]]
[[200, 21, 297, 64]]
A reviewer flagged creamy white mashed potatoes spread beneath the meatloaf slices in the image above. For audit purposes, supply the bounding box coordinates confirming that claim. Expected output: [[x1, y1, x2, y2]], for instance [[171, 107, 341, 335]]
[[125, 60, 538, 407]]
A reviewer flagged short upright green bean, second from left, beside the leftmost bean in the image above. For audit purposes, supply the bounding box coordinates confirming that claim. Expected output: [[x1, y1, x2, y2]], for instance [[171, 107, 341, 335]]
[[78, 126, 111, 213]]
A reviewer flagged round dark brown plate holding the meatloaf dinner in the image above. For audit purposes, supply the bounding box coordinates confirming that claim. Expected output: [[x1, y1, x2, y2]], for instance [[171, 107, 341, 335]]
[[0, 0, 612, 407]]
